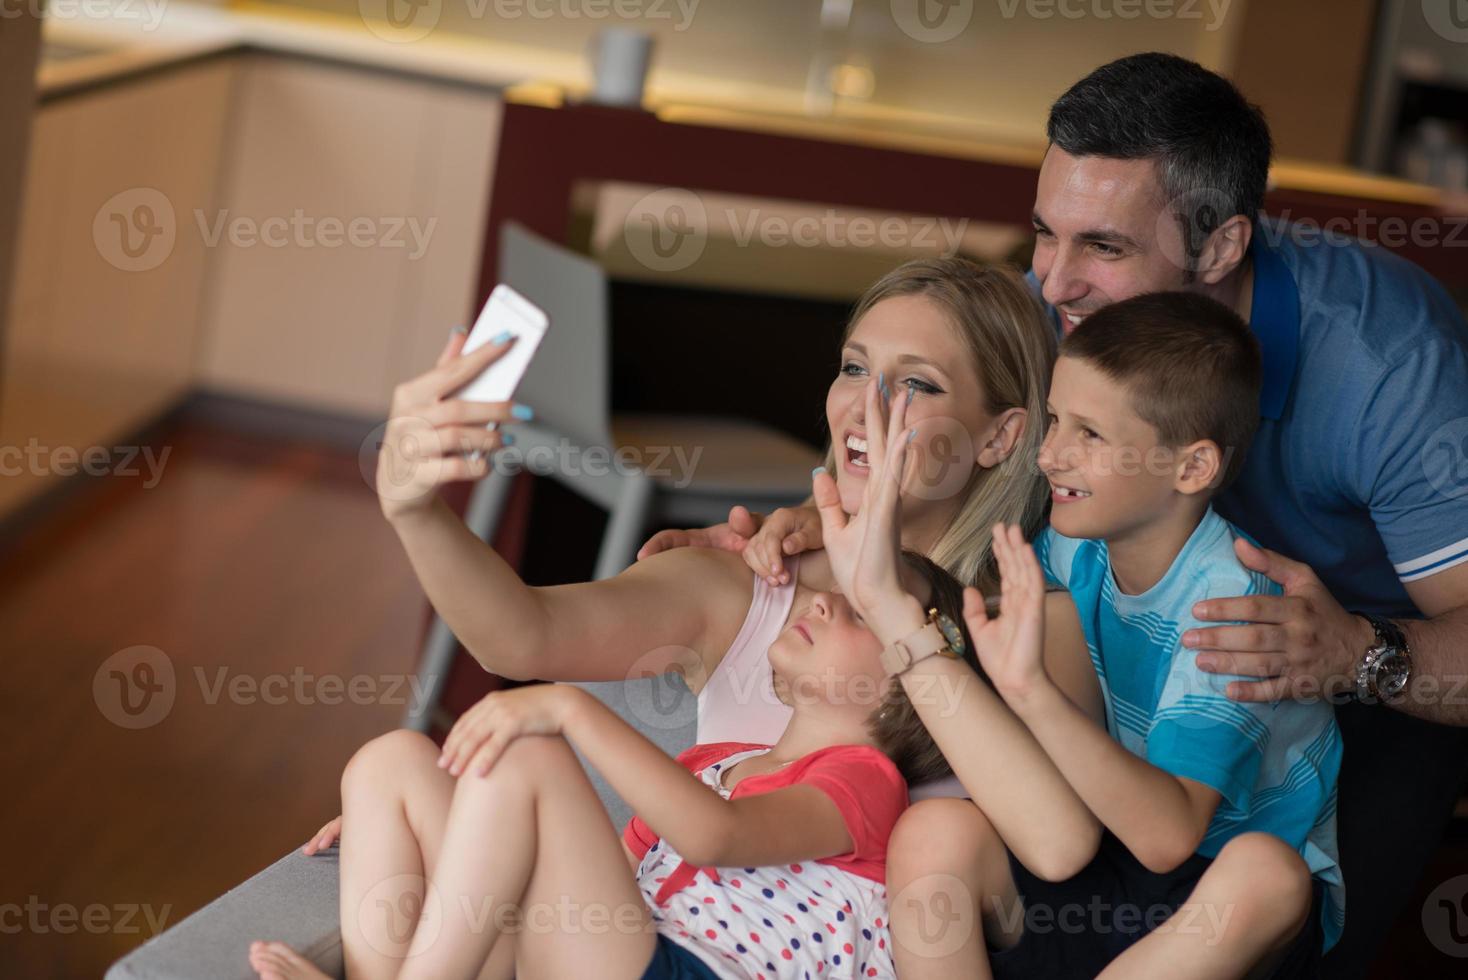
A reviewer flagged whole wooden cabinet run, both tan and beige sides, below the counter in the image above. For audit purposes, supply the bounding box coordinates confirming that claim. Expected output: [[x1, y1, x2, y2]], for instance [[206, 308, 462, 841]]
[[0, 54, 502, 515]]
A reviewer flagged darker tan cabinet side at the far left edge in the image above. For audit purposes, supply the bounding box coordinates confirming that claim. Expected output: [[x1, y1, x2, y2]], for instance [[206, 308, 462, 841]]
[[0, 60, 233, 512]]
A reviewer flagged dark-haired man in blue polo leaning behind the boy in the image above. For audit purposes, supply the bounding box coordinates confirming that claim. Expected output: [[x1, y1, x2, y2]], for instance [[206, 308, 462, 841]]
[[643, 54, 1468, 977]]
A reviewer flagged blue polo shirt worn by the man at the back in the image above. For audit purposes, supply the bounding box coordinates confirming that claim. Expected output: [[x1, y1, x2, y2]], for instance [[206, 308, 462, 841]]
[[1031, 220, 1468, 616]]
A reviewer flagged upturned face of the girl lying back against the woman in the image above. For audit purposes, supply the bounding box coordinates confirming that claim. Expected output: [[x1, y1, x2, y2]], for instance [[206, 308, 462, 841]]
[[769, 593, 887, 723]]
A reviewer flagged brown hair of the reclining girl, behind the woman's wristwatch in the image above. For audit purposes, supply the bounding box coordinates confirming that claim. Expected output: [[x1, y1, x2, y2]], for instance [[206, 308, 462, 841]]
[[869, 552, 989, 783]]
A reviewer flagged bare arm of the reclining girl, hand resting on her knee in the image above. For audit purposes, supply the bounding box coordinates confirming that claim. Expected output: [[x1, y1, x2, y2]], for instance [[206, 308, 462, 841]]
[[439, 684, 853, 867]]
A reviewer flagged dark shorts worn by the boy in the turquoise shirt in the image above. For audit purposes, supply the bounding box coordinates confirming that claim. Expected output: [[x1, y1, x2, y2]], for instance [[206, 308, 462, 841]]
[[989, 833, 1323, 980]]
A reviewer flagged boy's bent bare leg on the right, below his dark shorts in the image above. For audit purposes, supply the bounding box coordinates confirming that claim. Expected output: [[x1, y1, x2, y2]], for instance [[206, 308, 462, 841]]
[[1101, 833, 1312, 980]]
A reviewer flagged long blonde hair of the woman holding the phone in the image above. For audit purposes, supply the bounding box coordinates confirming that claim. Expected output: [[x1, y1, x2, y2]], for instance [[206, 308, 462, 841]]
[[825, 258, 1055, 591]]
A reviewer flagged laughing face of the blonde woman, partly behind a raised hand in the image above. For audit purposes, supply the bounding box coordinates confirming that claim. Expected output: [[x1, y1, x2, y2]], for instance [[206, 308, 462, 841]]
[[826, 290, 995, 524]]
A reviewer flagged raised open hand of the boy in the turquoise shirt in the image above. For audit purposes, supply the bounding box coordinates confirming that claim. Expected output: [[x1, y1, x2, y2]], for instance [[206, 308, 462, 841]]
[[963, 524, 1048, 701]]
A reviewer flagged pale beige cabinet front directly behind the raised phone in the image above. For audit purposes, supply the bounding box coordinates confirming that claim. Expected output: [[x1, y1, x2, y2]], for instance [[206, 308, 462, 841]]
[[195, 56, 501, 417]]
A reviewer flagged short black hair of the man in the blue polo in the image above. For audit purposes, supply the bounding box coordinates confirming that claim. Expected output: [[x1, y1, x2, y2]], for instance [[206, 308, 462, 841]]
[[1047, 51, 1274, 279]]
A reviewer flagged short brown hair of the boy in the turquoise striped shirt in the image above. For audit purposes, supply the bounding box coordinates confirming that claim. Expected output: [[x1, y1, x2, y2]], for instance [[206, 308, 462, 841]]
[[1060, 292, 1264, 493]]
